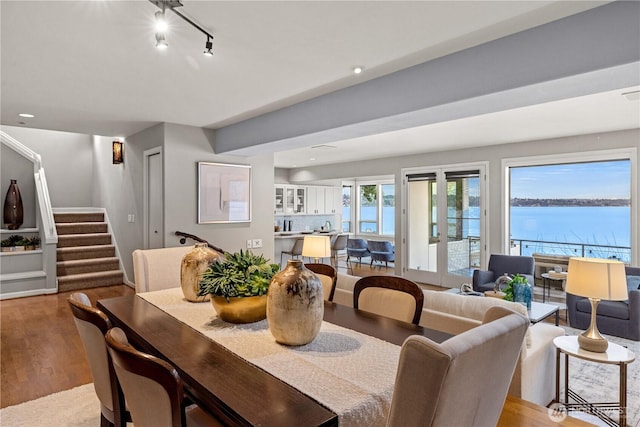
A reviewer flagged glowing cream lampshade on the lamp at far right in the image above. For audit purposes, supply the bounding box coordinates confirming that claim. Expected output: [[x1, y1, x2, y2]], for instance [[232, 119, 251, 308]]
[[565, 257, 629, 301]]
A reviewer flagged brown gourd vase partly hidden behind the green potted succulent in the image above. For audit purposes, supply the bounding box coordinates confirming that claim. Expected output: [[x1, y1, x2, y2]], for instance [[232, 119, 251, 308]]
[[180, 243, 222, 302]]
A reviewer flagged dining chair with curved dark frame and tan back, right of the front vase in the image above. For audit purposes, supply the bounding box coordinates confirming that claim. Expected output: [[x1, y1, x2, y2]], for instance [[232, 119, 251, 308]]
[[353, 276, 424, 325]]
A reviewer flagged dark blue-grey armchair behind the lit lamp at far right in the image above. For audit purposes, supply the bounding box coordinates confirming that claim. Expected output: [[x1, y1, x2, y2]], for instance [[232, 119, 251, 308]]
[[567, 267, 640, 341]]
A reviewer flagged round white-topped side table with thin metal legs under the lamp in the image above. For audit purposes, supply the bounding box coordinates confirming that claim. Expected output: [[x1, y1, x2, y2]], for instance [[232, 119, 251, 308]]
[[553, 335, 636, 427]]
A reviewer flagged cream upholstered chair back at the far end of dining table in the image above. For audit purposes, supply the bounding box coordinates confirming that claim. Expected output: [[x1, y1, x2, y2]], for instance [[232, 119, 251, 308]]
[[133, 246, 194, 293]]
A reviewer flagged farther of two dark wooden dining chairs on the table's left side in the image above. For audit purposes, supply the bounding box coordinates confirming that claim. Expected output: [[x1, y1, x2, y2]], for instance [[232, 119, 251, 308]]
[[67, 292, 131, 427]]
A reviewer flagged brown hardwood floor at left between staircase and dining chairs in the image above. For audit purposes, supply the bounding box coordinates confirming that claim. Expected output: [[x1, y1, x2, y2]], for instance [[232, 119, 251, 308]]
[[0, 285, 135, 408]]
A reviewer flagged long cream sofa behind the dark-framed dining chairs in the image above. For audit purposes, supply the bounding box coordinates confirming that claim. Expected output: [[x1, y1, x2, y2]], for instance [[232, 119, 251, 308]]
[[333, 273, 564, 406]]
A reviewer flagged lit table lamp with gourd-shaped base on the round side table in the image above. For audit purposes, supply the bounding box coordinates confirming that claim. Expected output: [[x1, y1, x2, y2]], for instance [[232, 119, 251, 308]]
[[565, 257, 629, 353]]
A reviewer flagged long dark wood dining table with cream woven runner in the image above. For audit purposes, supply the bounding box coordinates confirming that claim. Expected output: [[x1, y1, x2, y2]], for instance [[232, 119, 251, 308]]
[[97, 288, 451, 427]]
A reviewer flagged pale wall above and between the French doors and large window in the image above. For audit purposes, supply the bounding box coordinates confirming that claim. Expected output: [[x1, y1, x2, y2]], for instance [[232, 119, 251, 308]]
[[289, 129, 640, 274]]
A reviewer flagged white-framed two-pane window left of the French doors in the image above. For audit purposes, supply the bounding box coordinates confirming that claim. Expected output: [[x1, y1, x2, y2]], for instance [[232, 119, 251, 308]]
[[358, 182, 396, 236]]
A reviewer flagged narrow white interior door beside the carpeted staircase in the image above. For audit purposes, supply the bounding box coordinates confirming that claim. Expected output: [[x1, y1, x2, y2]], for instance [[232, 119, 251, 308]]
[[144, 148, 164, 249]]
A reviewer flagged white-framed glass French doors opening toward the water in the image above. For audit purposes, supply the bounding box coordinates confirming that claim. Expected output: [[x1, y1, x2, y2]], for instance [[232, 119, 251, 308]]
[[403, 164, 485, 287]]
